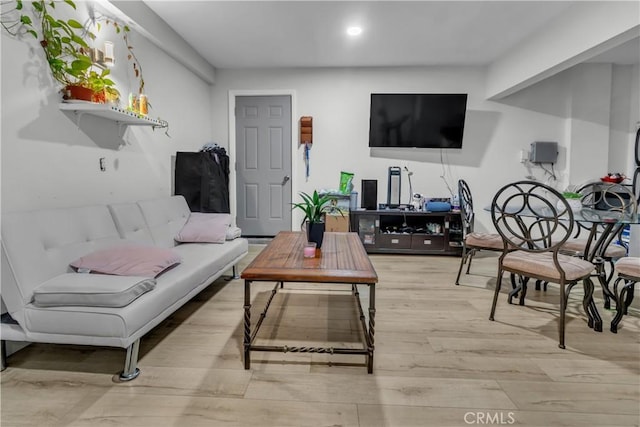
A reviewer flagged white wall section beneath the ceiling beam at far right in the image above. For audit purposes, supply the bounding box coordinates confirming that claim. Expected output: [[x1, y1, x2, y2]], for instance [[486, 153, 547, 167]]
[[490, 63, 640, 188]]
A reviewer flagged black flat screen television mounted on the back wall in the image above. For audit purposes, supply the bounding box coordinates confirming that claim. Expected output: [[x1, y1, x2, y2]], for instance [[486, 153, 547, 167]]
[[369, 93, 467, 149]]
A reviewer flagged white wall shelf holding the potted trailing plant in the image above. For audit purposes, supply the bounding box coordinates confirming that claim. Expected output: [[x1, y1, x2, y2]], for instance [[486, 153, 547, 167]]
[[60, 102, 169, 137]]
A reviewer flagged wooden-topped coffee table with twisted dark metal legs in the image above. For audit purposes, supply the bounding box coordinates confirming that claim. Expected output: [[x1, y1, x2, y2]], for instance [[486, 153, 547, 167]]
[[241, 231, 378, 373]]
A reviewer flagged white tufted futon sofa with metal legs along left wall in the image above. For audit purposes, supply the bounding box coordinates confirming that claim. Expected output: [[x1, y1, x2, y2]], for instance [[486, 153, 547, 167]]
[[0, 196, 248, 381]]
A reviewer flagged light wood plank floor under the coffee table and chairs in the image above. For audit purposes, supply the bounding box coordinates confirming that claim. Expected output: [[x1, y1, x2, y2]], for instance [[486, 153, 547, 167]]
[[0, 245, 640, 427]]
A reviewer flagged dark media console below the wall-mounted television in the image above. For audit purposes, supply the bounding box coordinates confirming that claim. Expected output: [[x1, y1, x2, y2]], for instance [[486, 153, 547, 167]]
[[349, 209, 462, 256]]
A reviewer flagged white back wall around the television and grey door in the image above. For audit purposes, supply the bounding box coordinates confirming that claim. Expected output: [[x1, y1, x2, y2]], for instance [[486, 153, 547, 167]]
[[213, 67, 565, 229]]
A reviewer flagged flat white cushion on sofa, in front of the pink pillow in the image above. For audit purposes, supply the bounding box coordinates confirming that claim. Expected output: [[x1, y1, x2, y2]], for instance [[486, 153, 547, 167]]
[[33, 273, 156, 307]]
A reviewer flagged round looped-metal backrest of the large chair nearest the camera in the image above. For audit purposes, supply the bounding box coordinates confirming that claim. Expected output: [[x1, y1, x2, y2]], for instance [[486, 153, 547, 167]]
[[491, 181, 573, 253]]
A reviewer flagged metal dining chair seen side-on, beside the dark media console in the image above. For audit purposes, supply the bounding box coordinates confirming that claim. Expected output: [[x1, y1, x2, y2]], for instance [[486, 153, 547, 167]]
[[456, 179, 504, 285]]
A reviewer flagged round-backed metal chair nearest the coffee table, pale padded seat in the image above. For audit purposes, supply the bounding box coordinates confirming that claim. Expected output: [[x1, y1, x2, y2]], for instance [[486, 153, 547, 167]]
[[489, 181, 602, 348]]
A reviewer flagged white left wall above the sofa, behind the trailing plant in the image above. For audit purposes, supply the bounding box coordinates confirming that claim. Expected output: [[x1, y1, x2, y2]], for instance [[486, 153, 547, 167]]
[[1, 2, 212, 212]]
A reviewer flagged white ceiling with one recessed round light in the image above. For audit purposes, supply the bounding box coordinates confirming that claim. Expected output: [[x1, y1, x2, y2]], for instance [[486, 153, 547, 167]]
[[145, 0, 640, 68]]
